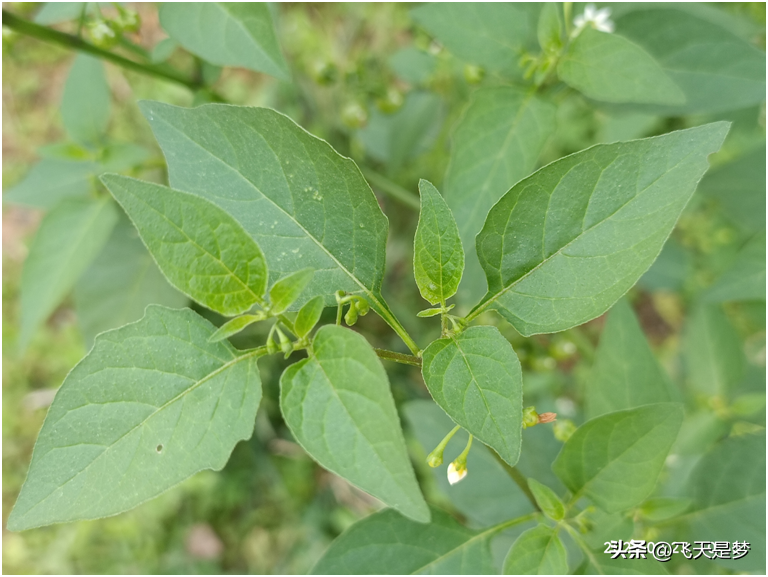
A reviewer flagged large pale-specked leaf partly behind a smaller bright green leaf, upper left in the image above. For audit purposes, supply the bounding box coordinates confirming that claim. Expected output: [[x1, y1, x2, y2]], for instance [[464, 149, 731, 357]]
[[142, 102, 418, 350]]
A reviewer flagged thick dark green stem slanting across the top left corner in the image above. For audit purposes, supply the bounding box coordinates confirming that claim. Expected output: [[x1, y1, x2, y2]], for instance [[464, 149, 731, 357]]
[[3, 10, 201, 90]]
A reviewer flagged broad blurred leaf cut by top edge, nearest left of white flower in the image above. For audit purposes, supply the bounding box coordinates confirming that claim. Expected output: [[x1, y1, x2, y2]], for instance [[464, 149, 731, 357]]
[[411, 2, 531, 73]]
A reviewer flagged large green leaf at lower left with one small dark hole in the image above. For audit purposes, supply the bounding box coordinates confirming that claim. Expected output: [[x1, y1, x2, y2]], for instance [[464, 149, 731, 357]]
[[8, 305, 261, 531]]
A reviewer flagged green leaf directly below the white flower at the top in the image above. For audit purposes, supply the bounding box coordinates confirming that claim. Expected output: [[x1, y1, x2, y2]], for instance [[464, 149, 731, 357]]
[[557, 26, 685, 104]]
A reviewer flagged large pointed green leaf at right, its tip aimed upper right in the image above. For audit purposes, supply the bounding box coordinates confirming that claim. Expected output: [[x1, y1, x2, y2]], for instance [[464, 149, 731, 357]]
[[472, 122, 729, 336]]
